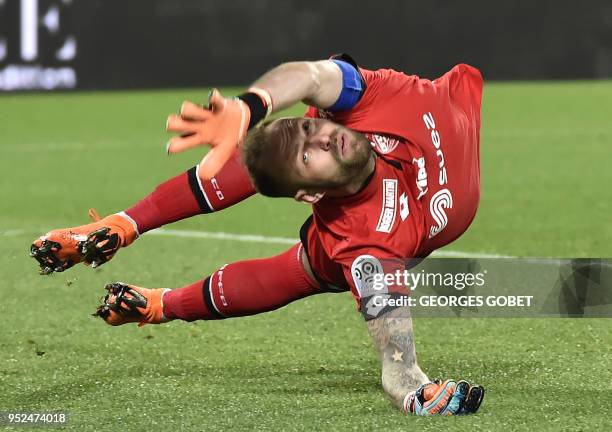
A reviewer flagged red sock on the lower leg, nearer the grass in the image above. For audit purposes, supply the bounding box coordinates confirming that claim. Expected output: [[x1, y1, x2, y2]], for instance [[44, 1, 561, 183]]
[[164, 244, 323, 321]]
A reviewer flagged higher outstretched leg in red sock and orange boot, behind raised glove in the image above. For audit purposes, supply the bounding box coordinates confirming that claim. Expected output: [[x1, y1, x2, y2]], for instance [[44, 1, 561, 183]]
[[30, 153, 255, 274]]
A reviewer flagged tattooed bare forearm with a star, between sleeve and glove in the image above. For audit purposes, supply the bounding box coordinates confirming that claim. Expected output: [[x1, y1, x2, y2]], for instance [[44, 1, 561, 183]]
[[367, 308, 429, 408]]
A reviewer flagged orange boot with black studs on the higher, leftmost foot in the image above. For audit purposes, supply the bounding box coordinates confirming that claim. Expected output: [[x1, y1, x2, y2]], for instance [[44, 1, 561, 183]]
[[30, 209, 138, 275]]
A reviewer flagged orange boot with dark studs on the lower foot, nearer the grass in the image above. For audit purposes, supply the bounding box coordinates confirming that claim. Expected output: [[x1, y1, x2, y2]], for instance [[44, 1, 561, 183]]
[[93, 282, 170, 327]]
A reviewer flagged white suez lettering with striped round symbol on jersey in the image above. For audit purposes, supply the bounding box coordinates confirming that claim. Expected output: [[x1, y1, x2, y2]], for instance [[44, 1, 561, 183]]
[[423, 112, 453, 238]]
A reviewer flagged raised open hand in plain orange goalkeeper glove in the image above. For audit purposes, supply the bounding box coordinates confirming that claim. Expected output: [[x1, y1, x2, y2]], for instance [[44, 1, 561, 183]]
[[166, 89, 251, 180]]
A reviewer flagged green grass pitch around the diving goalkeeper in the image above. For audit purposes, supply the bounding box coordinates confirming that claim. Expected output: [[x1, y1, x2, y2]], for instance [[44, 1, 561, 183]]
[[0, 82, 612, 431]]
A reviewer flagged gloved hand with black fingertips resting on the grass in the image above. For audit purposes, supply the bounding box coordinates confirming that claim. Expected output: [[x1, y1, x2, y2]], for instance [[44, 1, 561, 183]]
[[404, 380, 484, 416]]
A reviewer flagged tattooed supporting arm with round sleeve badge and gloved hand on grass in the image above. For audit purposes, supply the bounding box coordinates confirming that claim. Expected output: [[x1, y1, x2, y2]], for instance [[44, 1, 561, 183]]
[[344, 253, 484, 416]]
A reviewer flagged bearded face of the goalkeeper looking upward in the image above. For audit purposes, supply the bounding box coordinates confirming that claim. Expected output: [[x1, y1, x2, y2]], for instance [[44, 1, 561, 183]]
[[268, 118, 372, 190]]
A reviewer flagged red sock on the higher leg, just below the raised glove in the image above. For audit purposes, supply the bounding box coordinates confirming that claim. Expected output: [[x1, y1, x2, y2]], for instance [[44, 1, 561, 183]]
[[125, 152, 255, 234]]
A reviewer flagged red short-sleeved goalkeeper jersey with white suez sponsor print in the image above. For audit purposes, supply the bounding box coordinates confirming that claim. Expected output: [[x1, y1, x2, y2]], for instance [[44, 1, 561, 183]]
[[301, 64, 482, 298]]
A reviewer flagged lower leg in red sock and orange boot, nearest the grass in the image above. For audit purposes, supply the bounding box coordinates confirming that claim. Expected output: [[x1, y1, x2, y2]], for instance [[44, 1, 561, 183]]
[[96, 244, 323, 325]]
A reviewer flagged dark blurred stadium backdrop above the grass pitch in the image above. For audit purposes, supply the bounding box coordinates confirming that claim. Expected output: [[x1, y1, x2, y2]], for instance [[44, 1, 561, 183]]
[[0, 0, 612, 89]]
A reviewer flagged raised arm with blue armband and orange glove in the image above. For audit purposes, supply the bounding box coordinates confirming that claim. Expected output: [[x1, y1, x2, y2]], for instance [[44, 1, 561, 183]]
[[166, 60, 364, 180]]
